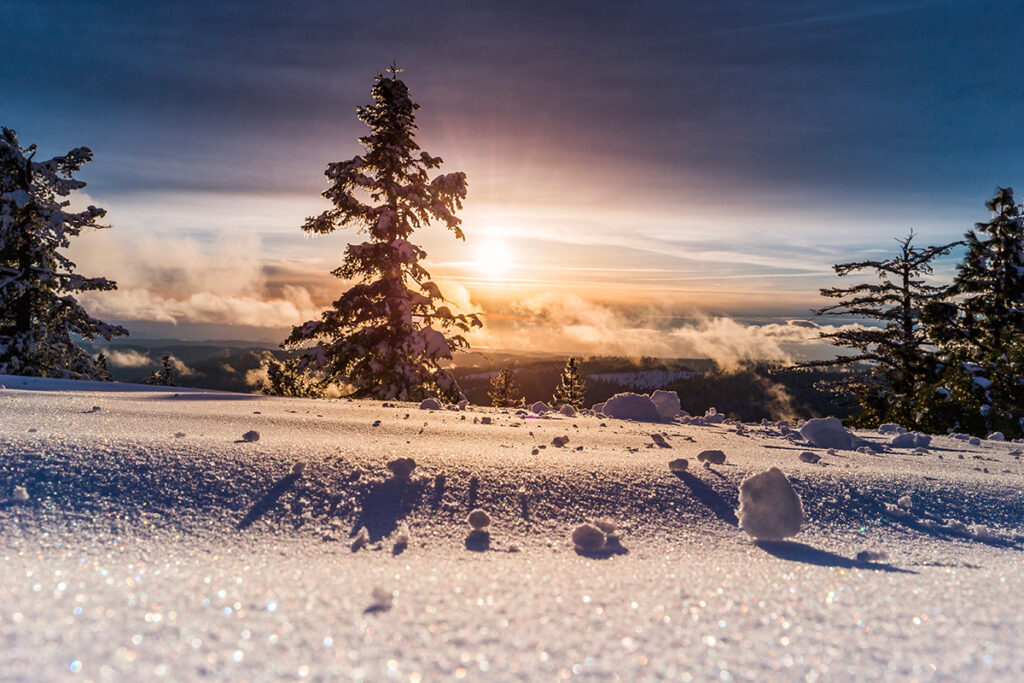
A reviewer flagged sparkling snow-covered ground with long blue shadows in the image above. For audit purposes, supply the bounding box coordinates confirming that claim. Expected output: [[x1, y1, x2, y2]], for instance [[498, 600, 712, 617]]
[[0, 377, 1024, 681]]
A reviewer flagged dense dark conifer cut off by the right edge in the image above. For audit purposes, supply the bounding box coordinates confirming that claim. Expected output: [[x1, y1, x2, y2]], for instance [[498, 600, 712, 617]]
[[924, 187, 1024, 437]]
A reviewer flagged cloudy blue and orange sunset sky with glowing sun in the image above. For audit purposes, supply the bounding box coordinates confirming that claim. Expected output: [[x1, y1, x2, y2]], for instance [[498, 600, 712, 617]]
[[0, 0, 1024, 356]]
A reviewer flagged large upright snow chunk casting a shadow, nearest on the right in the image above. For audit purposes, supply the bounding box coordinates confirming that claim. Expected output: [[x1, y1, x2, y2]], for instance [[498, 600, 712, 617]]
[[736, 466, 802, 540]]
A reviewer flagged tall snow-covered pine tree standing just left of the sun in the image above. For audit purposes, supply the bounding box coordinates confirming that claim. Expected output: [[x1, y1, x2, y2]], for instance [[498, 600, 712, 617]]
[[283, 65, 481, 401]]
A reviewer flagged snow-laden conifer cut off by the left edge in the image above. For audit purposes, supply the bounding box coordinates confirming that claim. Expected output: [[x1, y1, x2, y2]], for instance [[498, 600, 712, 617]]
[[0, 128, 128, 379]]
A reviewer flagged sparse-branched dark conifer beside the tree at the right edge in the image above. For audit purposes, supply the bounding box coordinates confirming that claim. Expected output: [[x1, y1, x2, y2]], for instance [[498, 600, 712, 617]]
[[801, 230, 959, 428]]
